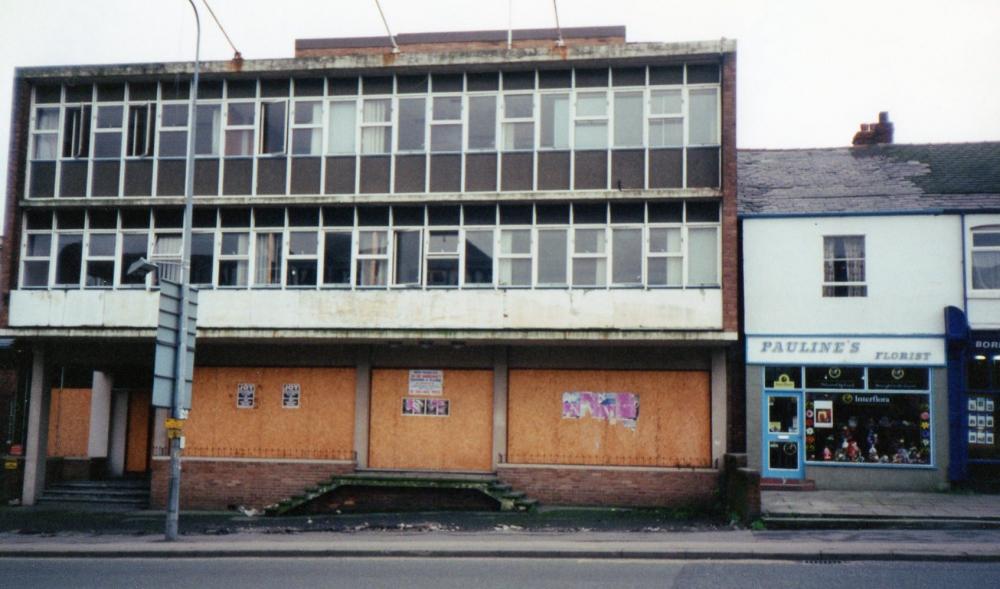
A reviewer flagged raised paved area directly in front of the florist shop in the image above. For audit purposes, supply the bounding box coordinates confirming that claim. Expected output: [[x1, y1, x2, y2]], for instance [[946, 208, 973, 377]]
[[761, 491, 1000, 529]]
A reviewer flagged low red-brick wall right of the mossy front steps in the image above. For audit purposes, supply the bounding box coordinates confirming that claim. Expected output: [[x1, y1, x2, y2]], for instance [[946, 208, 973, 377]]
[[497, 465, 719, 507]]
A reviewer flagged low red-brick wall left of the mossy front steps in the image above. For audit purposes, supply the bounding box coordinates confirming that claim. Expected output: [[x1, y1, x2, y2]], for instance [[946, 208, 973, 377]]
[[149, 460, 354, 509]]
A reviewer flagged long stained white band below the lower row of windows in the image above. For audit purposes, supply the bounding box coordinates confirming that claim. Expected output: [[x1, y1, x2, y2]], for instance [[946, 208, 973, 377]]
[[10, 289, 722, 330]]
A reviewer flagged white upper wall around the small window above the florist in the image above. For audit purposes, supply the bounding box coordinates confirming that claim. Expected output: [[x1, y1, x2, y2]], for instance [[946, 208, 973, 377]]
[[743, 215, 963, 335]]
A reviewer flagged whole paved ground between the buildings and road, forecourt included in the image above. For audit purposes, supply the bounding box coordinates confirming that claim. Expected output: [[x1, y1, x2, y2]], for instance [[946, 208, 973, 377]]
[[0, 491, 1000, 563]]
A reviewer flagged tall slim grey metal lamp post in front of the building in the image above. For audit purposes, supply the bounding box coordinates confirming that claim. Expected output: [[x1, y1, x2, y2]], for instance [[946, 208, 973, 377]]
[[166, 0, 201, 541]]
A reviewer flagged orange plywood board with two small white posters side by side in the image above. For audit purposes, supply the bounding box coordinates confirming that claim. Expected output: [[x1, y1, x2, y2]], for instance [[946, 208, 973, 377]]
[[184, 367, 355, 460]]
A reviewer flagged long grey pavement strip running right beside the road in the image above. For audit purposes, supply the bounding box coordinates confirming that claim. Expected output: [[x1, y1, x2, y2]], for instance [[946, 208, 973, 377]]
[[0, 530, 1000, 563]]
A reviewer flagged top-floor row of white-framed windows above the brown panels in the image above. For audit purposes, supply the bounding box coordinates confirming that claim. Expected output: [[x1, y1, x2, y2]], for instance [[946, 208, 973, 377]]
[[31, 87, 719, 161]]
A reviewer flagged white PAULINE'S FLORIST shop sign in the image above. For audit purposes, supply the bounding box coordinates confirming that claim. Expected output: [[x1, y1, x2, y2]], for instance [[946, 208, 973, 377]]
[[747, 335, 945, 366]]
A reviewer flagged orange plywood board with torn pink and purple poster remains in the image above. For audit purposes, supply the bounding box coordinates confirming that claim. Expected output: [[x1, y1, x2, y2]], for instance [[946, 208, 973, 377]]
[[507, 370, 711, 467]]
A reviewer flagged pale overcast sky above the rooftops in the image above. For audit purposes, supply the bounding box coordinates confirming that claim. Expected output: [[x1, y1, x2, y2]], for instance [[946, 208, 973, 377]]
[[0, 0, 1000, 227]]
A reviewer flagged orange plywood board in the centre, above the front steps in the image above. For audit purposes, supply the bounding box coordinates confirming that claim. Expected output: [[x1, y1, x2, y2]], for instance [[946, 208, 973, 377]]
[[368, 370, 493, 471]]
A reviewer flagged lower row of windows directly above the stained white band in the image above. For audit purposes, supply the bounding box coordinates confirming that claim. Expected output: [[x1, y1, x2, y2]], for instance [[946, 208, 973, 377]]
[[21, 201, 720, 288]]
